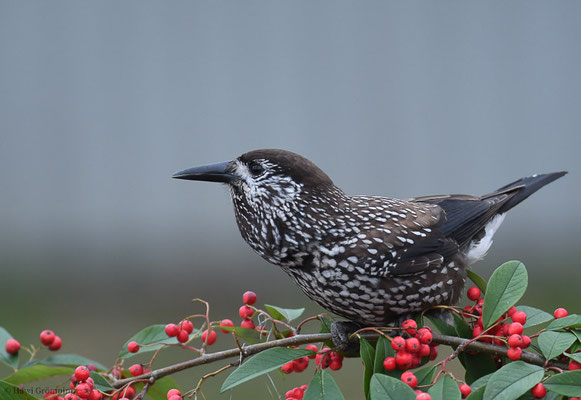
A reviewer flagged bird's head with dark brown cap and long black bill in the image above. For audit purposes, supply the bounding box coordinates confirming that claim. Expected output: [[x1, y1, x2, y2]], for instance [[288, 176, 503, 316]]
[[173, 149, 333, 208]]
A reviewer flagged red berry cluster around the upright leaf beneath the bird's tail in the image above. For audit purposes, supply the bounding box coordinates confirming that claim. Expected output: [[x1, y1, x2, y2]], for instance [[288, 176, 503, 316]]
[[464, 287, 531, 361]]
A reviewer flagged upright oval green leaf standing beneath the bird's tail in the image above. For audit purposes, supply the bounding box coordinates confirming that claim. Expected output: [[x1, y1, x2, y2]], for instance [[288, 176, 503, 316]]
[[482, 261, 528, 329]]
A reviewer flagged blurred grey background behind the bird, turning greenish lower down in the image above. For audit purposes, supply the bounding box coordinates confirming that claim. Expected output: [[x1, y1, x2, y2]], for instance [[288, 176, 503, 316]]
[[0, 1, 581, 398]]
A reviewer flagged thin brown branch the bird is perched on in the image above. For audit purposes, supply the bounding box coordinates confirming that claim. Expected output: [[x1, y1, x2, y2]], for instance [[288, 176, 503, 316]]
[[111, 333, 568, 388]]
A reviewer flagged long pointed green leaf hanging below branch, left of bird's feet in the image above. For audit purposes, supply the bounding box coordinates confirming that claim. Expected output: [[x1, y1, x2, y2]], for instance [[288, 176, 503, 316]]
[[220, 347, 315, 392]]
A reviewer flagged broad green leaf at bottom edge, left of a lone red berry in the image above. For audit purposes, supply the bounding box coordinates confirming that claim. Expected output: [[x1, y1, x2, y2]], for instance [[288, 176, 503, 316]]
[[484, 360, 545, 400]]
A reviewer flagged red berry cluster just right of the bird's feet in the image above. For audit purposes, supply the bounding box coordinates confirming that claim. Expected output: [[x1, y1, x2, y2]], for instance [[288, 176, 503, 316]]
[[383, 319, 438, 372]]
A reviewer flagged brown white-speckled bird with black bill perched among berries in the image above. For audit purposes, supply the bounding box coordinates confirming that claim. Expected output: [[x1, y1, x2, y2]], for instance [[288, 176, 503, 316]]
[[173, 149, 567, 326]]
